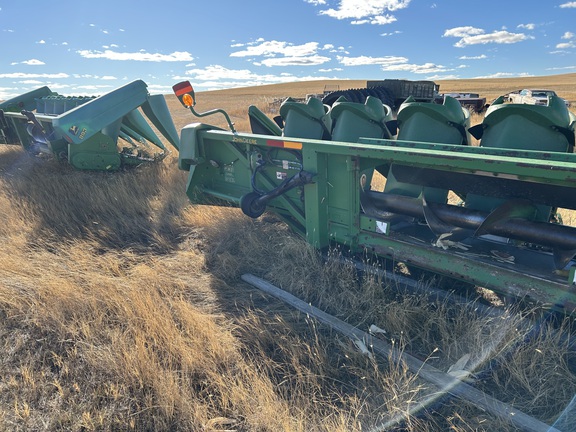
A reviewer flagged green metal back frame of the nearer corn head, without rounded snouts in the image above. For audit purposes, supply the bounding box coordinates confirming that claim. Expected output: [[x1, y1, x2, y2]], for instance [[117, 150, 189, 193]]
[[180, 123, 576, 310]]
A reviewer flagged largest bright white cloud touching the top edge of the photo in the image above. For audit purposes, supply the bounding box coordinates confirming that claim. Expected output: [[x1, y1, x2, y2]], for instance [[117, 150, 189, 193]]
[[309, 0, 411, 25]]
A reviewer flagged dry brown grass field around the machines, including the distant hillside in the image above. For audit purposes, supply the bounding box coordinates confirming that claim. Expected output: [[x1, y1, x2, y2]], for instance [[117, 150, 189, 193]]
[[0, 74, 576, 432]]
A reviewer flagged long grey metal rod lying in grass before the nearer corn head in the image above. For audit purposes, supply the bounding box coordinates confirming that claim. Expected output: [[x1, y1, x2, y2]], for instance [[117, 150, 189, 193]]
[[242, 274, 560, 432]]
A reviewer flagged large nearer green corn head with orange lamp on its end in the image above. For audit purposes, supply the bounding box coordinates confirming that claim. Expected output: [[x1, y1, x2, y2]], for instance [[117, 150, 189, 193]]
[[174, 82, 576, 311]]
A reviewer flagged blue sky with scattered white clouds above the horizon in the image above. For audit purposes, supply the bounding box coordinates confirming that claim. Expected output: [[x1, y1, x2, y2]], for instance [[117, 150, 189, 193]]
[[0, 0, 576, 100]]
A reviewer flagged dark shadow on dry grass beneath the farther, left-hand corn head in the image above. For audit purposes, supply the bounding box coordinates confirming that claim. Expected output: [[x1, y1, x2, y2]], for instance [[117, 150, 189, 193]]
[[0, 151, 188, 253]]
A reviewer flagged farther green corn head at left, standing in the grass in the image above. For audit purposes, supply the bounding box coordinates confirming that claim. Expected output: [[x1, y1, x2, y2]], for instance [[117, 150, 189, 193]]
[[0, 80, 179, 170]]
